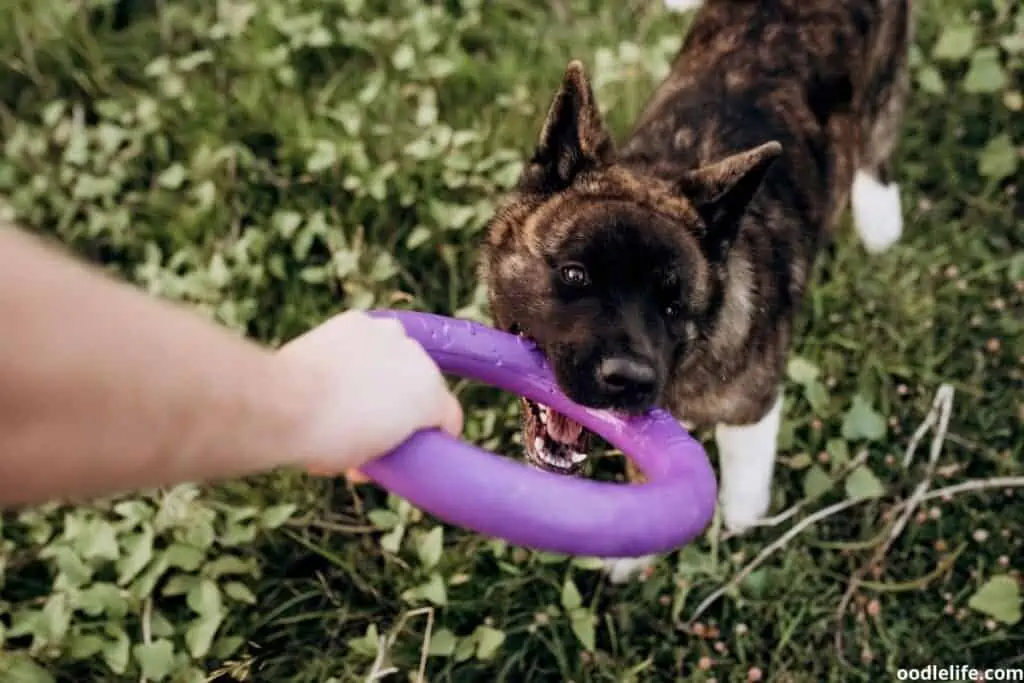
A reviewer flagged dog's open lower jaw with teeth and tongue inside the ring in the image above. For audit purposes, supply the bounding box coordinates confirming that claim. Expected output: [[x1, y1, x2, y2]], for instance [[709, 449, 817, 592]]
[[520, 398, 590, 474]]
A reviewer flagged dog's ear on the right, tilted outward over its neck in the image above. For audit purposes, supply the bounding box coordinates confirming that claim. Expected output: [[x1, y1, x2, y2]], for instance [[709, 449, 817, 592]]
[[677, 141, 782, 258]]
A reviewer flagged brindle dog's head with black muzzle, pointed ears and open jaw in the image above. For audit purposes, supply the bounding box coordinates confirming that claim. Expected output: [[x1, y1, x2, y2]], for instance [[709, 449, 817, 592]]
[[481, 61, 780, 472]]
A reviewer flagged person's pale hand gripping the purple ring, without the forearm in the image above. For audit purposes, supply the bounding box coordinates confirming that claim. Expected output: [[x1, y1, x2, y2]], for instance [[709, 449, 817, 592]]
[[278, 311, 463, 482]]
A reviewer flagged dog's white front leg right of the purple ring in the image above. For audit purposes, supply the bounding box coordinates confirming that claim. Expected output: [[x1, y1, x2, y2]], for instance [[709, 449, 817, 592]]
[[715, 391, 782, 533]]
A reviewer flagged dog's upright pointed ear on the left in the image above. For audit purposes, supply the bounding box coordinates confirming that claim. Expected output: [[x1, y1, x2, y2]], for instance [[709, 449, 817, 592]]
[[519, 59, 614, 194]]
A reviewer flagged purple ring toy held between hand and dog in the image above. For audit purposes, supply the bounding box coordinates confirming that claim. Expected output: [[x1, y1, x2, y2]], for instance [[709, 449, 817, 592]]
[[362, 310, 717, 557]]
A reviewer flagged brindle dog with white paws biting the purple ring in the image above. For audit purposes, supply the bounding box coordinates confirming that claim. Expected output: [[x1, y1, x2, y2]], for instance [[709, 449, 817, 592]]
[[480, 0, 912, 582]]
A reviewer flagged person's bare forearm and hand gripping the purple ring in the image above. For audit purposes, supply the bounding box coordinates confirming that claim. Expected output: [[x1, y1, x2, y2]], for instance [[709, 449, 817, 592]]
[[0, 224, 463, 508]]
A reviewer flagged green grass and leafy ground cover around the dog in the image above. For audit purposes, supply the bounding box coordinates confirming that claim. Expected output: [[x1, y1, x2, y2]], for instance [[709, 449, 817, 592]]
[[0, 0, 1024, 683]]
